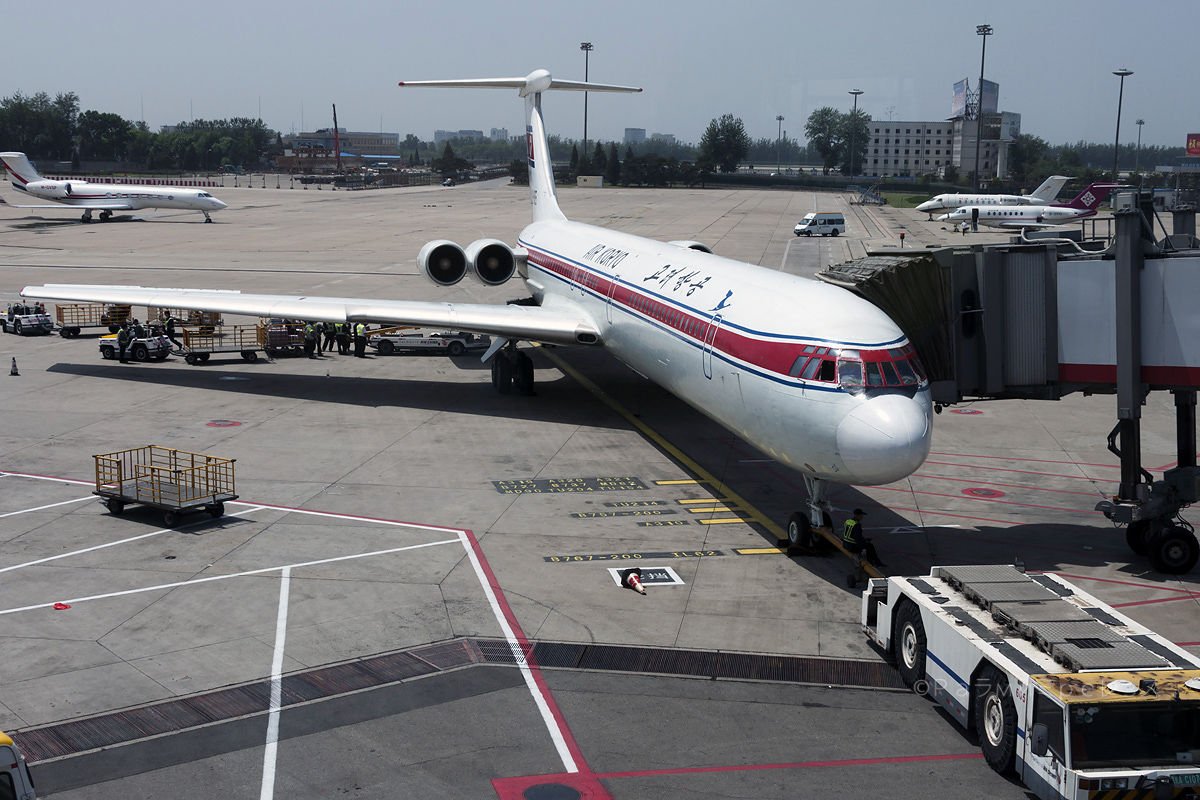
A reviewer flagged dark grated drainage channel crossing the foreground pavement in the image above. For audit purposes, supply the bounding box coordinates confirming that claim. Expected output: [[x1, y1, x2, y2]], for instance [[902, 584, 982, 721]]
[[12, 638, 904, 763]]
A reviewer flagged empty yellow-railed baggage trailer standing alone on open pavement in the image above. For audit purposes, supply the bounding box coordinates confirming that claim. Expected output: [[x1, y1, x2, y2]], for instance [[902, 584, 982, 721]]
[[92, 445, 238, 528]]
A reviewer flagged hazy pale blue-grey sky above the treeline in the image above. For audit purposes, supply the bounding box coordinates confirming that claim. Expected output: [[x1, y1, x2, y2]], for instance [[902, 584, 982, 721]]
[[7, 0, 1200, 146]]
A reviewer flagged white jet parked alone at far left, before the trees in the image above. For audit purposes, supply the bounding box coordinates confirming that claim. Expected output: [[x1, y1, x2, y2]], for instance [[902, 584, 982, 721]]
[[0, 152, 226, 222]]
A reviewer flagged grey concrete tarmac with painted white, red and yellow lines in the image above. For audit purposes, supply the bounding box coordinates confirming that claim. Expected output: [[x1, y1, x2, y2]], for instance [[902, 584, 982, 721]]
[[0, 179, 1200, 800]]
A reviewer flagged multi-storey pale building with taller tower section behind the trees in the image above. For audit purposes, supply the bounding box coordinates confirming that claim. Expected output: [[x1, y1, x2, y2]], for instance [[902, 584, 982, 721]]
[[863, 79, 1021, 184]]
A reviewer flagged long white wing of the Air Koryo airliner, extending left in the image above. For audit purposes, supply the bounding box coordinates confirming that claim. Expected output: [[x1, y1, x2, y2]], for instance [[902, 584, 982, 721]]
[[22, 284, 600, 344]]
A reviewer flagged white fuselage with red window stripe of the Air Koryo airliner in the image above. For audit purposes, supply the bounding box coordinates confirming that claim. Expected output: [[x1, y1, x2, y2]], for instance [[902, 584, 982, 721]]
[[518, 215, 931, 485]]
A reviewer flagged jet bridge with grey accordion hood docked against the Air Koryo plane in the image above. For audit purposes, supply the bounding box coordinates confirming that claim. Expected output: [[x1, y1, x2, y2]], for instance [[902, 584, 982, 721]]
[[817, 193, 1200, 573]]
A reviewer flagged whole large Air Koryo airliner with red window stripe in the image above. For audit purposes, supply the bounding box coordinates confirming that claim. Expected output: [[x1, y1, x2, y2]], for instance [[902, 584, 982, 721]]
[[22, 70, 931, 541]]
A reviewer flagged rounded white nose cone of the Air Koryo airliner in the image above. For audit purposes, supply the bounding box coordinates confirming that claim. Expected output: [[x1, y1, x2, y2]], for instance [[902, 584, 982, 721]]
[[838, 395, 932, 486]]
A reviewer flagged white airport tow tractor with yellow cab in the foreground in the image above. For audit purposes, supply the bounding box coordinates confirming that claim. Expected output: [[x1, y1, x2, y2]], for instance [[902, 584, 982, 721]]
[[862, 565, 1200, 800]]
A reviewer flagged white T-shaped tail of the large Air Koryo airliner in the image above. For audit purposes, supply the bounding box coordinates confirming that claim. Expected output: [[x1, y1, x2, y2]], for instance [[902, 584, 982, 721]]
[[400, 70, 642, 222]]
